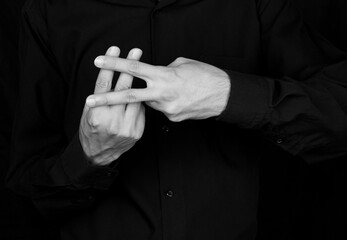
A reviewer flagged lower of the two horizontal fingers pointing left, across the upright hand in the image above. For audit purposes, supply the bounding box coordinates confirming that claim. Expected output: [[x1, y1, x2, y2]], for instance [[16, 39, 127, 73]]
[[86, 88, 159, 107]]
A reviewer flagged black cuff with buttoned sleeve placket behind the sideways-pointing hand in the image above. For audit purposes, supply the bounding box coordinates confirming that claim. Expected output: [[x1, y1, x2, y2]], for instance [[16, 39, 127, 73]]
[[217, 70, 308, 155]]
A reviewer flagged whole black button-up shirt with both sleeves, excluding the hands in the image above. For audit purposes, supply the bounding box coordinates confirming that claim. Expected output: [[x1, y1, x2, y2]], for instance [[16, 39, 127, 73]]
[[8, 0, 347, 240]]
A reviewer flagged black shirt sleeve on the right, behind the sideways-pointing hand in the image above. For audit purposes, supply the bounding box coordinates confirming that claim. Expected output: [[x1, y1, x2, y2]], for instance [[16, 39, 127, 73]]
[[218, 0, 347, 163]]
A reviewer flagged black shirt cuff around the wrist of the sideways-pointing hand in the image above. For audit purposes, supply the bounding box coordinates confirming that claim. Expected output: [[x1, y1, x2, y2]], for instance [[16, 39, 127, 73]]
[[217, 70, 271, 128]]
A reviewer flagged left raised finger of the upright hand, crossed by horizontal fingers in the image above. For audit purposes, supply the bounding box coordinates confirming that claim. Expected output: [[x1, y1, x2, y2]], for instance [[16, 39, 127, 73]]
[[94, 47, 120, 93]]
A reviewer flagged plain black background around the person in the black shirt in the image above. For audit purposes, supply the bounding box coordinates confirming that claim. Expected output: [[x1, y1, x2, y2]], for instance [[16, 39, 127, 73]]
[[0, 0, 347, 240]]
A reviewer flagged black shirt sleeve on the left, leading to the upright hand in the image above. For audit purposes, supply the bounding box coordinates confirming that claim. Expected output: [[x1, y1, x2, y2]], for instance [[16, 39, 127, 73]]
[[7, 1, 117, 221]]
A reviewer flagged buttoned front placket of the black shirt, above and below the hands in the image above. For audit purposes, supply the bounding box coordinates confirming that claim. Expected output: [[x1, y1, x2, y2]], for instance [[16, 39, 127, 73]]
[[151, 3, 185, 240]]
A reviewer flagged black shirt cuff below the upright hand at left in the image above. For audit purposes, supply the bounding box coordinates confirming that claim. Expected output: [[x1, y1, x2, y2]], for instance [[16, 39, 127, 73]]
[[62, 134, 118, 189]]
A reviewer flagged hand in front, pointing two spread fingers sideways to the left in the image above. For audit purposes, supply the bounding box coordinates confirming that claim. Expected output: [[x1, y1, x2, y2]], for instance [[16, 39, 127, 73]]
[[87, 56, 230, 121]]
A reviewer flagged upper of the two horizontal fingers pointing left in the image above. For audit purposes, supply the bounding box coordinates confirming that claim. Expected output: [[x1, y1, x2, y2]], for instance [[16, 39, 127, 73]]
[[94, 56, 166, 81]]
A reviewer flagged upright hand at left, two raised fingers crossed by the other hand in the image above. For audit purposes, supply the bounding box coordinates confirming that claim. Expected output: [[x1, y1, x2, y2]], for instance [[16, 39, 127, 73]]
[[79, 47, 145, 165]]
